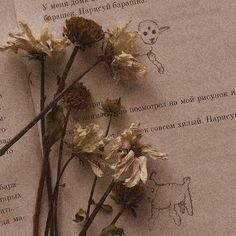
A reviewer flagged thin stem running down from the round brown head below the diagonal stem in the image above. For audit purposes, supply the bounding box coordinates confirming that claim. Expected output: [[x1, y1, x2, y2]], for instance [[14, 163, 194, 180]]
[[54, 109, 71, 236]]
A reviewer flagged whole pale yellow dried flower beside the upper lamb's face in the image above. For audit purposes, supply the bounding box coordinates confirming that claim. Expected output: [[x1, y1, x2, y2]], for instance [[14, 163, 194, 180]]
[[103, 24, 146, 82]]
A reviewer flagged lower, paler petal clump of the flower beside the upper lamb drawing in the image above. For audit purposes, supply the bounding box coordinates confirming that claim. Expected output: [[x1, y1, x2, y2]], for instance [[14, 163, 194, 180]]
[[110, 52, 146, 82]]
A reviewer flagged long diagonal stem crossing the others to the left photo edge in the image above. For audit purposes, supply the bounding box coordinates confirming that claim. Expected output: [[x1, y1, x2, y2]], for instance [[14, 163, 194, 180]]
[[0, 58, 103, 156]]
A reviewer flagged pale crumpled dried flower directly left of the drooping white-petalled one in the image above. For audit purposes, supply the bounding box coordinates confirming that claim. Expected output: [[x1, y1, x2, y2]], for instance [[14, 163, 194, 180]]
[[69, 124, 109, 177]]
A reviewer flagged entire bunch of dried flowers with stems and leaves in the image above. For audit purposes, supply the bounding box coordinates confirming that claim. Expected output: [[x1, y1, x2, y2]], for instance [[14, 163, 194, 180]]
[[0, 17, 167, 236]]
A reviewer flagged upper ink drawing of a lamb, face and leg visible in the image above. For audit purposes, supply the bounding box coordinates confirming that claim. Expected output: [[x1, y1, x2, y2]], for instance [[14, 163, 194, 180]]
[[138, 20, 170, 74]]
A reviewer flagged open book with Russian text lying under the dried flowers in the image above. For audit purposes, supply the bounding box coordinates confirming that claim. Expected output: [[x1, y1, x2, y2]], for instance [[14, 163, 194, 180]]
[[0, 0, 236, 236]]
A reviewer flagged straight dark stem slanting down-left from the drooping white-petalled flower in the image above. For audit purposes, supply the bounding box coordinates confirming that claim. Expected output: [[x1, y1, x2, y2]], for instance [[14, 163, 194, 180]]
[[79, 180, 115, 236]]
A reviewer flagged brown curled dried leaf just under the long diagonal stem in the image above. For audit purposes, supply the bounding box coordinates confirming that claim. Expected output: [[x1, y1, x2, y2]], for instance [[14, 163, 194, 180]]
[[44, 105, 65, 148]]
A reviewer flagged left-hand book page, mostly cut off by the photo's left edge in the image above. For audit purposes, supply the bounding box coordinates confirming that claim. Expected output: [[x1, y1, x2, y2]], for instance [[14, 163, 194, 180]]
[[0, 1, 41, 236]]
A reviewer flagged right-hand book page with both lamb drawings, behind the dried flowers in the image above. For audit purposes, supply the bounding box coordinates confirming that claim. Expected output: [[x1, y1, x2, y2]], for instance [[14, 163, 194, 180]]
[[15, 0, 236, 236]]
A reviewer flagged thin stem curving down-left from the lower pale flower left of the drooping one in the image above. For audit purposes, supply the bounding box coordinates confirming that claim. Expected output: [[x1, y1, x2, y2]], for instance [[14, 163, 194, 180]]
[[44, 156, 76, 236]]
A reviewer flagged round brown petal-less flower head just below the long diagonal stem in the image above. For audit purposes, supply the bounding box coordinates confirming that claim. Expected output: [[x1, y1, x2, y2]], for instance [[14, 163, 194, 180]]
[[64, 83, 91, 110]]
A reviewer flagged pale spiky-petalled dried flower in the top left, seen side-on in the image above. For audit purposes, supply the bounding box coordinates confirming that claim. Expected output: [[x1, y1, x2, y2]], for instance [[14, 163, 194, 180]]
[[0, 22, 69, 59]]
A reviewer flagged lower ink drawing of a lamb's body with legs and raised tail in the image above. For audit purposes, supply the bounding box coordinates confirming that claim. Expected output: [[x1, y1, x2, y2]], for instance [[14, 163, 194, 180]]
[[147, 172, 193, 230]]
